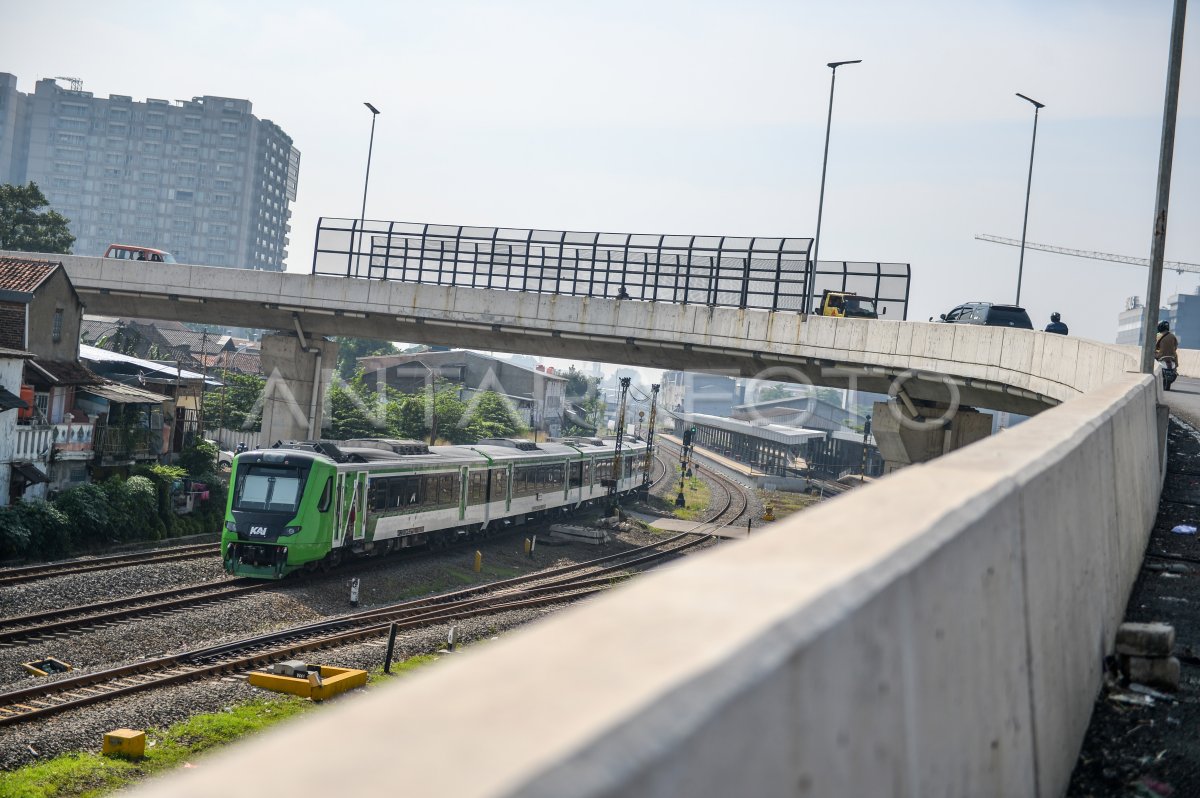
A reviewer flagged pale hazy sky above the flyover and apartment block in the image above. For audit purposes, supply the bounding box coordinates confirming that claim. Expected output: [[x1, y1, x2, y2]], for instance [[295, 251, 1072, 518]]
[[0, 0, 1200, 346]]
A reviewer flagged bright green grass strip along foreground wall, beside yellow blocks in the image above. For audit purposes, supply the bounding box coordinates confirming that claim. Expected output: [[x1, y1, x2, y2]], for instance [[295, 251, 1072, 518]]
[[0, 654, 438, 798]]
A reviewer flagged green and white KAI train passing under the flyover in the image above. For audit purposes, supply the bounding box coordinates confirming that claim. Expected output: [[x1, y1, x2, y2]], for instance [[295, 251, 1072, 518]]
[[221, 438, 646, 578]]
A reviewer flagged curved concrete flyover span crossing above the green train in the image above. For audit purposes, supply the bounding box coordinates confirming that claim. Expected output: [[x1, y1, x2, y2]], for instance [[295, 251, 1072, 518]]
[[51, 253, 1126, 414]]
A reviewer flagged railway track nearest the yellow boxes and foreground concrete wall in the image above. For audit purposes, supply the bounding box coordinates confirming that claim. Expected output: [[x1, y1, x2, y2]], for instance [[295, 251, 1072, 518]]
[[0, 533, 710, 726]]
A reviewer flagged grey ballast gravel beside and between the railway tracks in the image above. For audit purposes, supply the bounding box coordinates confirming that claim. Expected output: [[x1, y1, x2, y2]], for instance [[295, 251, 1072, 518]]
[[0, 528, 696, 769]]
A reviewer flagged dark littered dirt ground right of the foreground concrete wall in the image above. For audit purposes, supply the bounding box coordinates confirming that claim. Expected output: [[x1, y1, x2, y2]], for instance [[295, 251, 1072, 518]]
[[1067, 420, 1200, 798]]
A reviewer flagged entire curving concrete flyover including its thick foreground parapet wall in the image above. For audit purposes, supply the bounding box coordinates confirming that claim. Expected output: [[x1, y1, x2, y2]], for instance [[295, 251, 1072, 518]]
[[35, 252, 1163, 798]]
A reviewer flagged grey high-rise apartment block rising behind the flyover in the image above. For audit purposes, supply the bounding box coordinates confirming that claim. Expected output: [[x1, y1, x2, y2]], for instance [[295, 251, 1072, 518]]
[[0, 72, 300, 271]]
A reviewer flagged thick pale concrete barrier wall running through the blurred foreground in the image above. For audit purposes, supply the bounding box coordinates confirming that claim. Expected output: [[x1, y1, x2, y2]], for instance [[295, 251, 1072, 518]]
[[142, 374, 1160, 798]]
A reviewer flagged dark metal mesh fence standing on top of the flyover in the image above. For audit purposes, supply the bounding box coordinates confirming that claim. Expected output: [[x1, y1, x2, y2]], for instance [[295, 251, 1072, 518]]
[[312, 217, 910, 319]]
